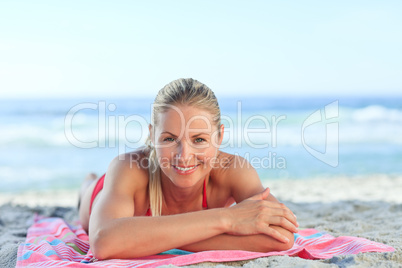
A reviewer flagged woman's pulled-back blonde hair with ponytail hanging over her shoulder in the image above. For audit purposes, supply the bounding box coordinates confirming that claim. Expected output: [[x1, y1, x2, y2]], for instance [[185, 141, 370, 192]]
[[146, 78, 221, 216]]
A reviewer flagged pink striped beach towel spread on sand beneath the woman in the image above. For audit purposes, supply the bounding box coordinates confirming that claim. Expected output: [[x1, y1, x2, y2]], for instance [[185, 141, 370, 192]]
[[17, 216, 394, 267]]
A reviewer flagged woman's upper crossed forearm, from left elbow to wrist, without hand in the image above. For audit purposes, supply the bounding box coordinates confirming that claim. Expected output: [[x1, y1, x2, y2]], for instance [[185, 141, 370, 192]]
[[90, 209, 227, 259]]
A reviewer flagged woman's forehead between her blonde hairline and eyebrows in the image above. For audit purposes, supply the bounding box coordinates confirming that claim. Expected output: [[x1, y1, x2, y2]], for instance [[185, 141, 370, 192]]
[[156, 106, 214, 132]]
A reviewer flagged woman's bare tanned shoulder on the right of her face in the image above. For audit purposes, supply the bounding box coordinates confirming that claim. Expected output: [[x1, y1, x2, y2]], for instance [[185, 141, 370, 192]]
[[213, 152, 263, 202]]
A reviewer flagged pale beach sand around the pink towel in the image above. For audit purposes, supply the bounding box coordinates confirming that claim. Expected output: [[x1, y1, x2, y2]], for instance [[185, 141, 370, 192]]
[[0, 175, 402, 267]]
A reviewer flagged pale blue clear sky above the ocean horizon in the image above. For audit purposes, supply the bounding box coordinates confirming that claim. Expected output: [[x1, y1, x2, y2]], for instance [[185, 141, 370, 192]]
[[0, 0, 402, 98]]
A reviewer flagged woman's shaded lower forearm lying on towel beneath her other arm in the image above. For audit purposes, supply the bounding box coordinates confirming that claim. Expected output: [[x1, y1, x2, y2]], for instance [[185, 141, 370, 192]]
[[180, 226, 294, 252]]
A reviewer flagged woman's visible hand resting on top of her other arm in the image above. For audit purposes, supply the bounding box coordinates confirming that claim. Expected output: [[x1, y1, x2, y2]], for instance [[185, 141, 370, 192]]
[[227, 188, 299, 243]]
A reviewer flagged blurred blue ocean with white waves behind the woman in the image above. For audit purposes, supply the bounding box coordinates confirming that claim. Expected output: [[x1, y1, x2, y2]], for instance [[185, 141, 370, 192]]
[[0, 97, 402, 193]]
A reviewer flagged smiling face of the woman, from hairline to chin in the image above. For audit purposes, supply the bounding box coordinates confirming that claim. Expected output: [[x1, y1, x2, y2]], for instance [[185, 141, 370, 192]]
[[150, 105, 223, 188]]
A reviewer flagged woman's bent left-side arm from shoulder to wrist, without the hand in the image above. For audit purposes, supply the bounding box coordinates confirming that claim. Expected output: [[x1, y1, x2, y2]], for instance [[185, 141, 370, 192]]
[[89, 159, 227, 259]]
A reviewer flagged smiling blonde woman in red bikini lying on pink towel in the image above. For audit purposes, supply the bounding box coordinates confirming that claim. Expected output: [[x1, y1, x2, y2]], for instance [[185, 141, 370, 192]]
[[80, 79, 298, 259]]
